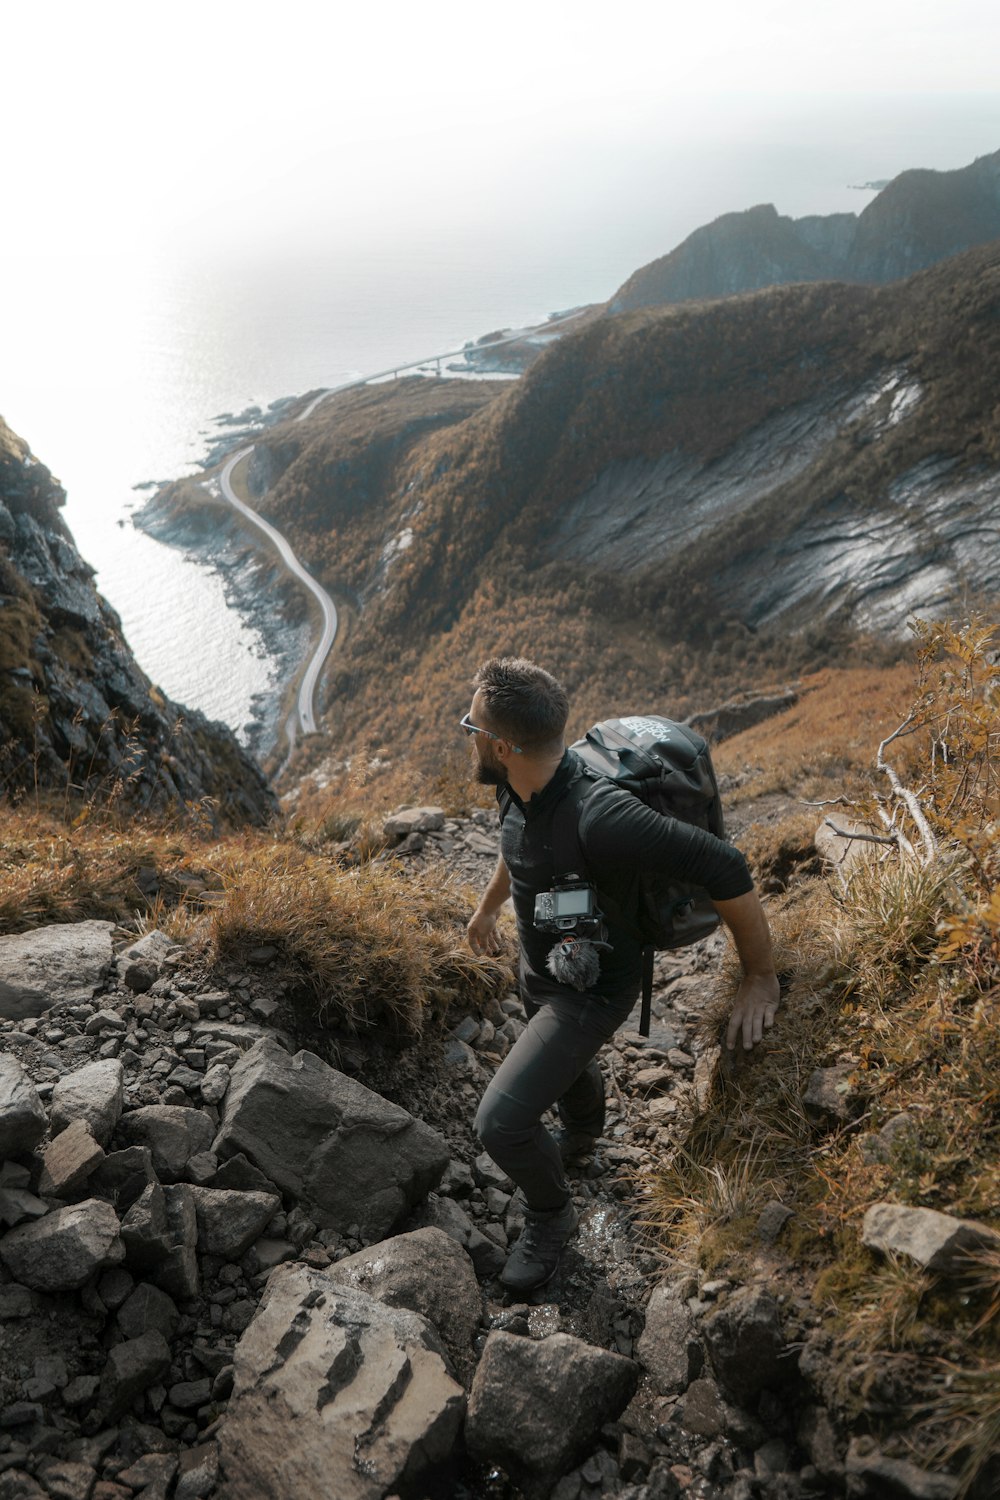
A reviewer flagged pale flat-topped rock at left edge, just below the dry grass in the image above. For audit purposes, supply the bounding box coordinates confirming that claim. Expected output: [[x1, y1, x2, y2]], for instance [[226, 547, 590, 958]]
[[0, 923, 114, 1020]]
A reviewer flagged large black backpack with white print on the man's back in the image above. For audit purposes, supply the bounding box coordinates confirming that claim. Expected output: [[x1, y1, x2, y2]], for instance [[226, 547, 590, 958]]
[[553, 714, 726, 1037]]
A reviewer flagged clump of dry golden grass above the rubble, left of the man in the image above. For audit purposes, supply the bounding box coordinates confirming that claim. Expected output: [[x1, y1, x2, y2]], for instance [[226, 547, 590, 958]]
[[211, 840, 513, 1040]]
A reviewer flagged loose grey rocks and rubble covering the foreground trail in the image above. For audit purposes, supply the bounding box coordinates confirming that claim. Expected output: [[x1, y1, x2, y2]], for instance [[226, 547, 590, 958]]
[[0, 810, 969, 1500]]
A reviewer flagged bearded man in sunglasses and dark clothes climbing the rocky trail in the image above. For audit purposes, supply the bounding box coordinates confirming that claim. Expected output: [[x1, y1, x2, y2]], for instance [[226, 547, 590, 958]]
[[462, 657, 778, 1292]]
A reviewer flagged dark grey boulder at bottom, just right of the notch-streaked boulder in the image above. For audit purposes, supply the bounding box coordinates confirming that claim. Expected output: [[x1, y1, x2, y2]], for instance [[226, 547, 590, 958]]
[[465, 1329, 639, 1478]]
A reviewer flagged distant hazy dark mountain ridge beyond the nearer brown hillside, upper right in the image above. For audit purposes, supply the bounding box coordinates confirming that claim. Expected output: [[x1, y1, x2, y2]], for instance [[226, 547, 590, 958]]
[[610, 152, 1000, 312]]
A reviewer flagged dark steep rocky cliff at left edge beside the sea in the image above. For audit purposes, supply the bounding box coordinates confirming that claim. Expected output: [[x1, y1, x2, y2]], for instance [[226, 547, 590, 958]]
[[0, 419, 276, 824]]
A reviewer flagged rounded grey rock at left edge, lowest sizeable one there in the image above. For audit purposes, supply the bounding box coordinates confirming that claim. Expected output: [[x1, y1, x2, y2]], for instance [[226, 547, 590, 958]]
[[0, 1199, 124, 1292]]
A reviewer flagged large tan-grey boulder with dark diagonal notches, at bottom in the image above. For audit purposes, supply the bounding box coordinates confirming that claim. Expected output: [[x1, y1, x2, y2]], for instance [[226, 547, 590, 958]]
[[219, 1266, 465, 1500]]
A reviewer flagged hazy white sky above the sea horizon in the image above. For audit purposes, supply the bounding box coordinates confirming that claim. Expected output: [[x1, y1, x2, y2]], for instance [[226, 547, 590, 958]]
[[0, 0, 1000, 254]]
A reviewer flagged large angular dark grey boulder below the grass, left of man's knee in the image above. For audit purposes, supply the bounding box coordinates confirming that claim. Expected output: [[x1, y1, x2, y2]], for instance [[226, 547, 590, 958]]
[[211, 1037, 450, 1242]]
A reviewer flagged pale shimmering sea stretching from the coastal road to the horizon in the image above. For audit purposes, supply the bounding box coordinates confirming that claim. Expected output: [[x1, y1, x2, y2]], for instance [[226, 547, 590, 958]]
[[0, 114, 996, 747]]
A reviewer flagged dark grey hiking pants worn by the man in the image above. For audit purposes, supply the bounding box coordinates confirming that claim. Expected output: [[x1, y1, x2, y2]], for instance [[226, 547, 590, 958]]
[[475, 963, 637, 1212]]
